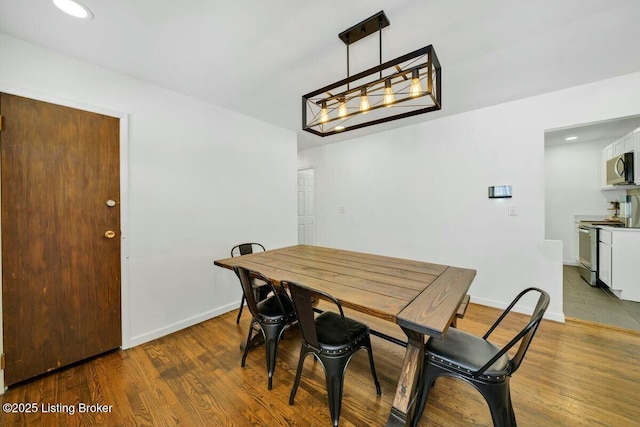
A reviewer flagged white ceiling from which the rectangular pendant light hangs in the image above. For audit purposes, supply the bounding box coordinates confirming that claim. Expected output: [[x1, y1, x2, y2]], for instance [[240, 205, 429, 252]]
[[0, 0, 640, 149]]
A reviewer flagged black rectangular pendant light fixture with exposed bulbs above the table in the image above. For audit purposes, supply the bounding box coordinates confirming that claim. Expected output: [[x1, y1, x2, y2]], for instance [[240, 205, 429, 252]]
[[302, 11, 442, 136]]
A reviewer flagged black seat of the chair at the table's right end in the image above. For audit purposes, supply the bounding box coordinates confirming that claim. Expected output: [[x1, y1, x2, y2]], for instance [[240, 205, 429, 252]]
[[426, 328, 509, 377]]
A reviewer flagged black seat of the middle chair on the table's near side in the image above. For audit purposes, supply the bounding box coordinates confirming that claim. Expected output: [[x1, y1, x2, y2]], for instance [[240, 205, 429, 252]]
[[315, 311, 369, 353]]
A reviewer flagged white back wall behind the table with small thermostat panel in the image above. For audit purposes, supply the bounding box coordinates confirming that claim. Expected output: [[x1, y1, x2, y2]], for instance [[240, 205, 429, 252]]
[[298, 73, 640, 320]]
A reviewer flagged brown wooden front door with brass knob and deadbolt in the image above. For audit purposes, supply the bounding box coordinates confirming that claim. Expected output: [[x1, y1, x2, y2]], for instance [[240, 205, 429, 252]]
[[0, 93, 122, 385]]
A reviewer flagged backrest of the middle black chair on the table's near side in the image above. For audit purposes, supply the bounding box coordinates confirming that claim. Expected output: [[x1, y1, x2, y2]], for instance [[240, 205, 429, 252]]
[[281, 280, 353, 351]]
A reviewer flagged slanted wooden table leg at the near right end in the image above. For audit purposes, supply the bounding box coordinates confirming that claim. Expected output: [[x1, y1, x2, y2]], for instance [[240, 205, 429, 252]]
[[387, 328, 424, 427]]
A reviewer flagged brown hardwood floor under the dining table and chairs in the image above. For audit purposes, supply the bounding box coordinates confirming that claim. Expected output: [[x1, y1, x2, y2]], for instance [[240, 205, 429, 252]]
[[0, 304, 640, 427]]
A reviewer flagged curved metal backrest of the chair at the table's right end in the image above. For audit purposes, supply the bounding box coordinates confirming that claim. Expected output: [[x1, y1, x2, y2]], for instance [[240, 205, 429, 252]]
[[474, 287, 551, 376]]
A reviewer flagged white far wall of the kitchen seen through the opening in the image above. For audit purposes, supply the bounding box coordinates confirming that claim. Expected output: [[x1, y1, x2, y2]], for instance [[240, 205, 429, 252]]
[[544, 138, 626, 265]]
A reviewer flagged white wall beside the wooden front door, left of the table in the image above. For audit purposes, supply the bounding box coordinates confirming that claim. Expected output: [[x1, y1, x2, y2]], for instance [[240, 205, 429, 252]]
[[0, 33, 297, 385]]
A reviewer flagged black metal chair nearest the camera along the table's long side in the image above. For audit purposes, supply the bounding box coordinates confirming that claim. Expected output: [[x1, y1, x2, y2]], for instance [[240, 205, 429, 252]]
[[281, 281, 380, 426]]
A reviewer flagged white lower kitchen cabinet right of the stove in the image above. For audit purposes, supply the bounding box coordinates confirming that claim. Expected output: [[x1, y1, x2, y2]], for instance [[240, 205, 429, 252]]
[[598, 227, 640, 302]]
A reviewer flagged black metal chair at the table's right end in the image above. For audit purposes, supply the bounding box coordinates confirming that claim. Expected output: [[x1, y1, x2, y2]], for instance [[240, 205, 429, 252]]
[[412, 288, 550, 427]]
